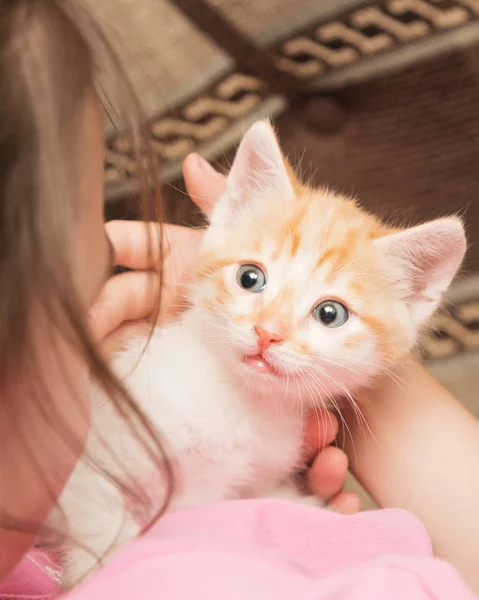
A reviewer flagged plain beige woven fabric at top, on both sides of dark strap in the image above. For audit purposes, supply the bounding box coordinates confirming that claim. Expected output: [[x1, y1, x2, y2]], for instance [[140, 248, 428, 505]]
[[85, 0, 350, 122]]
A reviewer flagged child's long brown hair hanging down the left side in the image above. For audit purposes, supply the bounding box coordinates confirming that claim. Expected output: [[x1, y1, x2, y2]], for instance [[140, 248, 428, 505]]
[[0, 0, 171, 530]]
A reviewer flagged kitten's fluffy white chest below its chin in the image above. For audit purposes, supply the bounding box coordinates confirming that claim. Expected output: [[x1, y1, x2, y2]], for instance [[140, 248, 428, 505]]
[[95, 314, 302, 508]]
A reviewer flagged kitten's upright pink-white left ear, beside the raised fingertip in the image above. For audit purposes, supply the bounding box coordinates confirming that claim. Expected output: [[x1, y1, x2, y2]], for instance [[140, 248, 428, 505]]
[[212, 121, 295, 224]]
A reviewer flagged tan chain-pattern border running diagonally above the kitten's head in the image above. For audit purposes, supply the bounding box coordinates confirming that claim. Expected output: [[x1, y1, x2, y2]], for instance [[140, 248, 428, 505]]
[[106, 0, 479, 200]]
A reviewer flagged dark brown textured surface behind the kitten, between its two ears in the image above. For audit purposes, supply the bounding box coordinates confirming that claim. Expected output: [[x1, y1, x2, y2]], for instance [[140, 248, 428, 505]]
[[166, 48, 479, 271]]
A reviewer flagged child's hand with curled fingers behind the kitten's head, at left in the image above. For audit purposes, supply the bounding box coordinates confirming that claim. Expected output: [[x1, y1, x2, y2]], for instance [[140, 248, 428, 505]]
[[90, 154, 226, 355]]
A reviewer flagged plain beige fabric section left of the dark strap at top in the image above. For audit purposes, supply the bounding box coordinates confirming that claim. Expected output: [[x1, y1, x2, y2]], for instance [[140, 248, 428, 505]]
[[86, 0, 232, 124]]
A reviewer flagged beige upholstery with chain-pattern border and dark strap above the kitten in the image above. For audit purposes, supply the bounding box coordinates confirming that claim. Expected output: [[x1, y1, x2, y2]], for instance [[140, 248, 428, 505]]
[[105, 0, 479, 191]]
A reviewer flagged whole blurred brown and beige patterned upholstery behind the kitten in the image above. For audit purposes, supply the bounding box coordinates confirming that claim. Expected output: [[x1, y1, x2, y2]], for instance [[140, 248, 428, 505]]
[[90, 0, 479, 506]]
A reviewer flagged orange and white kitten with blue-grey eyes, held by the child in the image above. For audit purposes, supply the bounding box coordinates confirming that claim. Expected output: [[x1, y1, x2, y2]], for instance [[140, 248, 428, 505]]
[[51, 122, 466, 587]]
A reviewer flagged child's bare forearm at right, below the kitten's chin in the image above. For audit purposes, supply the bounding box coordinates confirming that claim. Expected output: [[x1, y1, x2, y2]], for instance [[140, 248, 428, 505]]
[[345, 361, 479, 593]]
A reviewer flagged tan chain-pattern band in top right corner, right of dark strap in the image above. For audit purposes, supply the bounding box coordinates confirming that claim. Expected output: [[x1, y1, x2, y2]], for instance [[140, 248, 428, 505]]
[[277, 0, 479, 84]]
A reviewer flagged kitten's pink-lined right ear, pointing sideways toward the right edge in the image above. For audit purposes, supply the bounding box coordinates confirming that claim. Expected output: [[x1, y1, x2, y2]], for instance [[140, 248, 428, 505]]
[[374, 217, 466, 326]]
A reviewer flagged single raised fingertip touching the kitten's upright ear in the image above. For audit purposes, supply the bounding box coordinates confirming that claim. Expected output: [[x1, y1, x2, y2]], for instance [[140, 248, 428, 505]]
[[183, 154, 226, 215]]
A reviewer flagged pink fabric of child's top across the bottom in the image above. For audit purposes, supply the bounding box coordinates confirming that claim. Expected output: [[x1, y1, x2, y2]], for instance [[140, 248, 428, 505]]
[[0, 500, 475, 600]]
